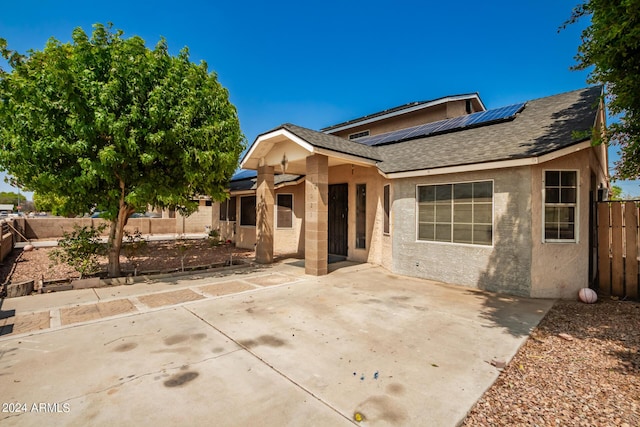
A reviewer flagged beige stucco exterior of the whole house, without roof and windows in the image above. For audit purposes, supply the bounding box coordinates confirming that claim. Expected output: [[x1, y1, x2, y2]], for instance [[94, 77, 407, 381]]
[[229, 88, 609, 298]]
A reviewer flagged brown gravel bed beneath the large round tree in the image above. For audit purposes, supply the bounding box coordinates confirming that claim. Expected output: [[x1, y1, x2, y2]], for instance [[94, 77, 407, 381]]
[[0, 240, 255, 284]]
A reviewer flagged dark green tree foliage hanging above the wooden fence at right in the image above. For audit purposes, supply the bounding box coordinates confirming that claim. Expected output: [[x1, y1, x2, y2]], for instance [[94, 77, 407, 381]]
[[564, 0, 640, 179]]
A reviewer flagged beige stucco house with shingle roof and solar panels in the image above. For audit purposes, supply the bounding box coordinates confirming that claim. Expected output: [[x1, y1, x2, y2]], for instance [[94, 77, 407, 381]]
[[214, 87, 609, 298]]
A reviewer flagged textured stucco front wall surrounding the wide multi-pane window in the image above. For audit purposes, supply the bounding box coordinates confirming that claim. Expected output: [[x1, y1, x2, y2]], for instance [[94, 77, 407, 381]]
[[392, 167, 531, 295]]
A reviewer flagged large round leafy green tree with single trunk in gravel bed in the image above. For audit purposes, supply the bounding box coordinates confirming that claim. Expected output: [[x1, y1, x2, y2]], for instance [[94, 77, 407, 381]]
[[0, 24, 245, 276]]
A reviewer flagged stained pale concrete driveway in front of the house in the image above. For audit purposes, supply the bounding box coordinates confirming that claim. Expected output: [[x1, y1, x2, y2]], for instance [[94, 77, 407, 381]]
[[0, 260, 552, 426]]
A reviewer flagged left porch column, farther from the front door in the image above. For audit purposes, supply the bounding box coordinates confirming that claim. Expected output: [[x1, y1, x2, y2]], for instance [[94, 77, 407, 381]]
[[256, 166, 275, 264]]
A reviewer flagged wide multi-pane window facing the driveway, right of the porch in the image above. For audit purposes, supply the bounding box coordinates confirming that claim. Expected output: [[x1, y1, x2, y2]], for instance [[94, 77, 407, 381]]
[[417, 181, 493, 246]]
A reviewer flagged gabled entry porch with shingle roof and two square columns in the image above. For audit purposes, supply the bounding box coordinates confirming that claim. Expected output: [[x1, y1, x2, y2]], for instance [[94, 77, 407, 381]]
[[241, 124, 380, 276]]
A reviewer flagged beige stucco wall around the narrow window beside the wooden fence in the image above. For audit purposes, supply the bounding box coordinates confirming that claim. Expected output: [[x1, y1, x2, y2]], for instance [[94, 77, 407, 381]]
[[531, 146, 606, 299]]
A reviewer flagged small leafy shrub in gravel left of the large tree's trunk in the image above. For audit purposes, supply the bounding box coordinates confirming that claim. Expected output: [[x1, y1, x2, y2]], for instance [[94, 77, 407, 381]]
[[49, 224, 106, 279]]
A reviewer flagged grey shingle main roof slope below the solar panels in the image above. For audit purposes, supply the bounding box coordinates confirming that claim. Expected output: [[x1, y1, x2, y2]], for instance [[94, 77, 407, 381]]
[[377, 86, 602, 173]]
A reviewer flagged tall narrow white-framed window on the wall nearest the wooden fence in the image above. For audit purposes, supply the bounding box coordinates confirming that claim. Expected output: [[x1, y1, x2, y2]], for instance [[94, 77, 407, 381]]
[[544, 171, 578, 242]]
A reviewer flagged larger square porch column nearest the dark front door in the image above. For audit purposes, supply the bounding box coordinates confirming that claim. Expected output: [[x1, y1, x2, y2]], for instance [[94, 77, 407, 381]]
[[304, 154, 329, 276]]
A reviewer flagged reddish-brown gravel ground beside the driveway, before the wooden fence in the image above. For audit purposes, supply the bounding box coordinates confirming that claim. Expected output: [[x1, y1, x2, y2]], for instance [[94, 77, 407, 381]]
[[463, 298, 640, 427]]
